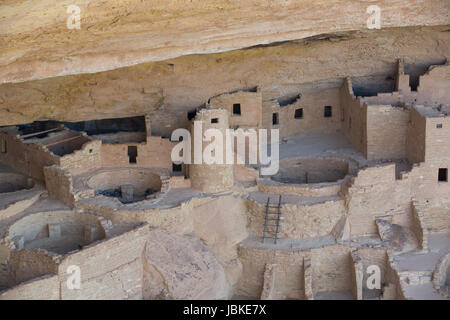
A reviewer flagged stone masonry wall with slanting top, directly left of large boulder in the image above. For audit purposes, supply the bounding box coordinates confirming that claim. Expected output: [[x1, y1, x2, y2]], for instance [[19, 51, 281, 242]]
[[58, 225, 149, 300]]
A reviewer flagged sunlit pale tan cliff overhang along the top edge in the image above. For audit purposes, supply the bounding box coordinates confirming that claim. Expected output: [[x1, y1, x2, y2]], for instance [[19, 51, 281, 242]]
[[0, 0, 450, 83]]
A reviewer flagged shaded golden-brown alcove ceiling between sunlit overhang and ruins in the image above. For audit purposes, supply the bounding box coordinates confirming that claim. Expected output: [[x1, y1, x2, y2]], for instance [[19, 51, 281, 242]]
[[0, 27, 450, 129]]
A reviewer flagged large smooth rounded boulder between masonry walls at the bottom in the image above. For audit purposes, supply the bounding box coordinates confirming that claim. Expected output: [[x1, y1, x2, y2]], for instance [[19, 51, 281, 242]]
[[143, 229, 229, 300]]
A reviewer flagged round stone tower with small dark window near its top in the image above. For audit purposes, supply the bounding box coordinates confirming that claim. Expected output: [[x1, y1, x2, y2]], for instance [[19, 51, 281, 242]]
[[189, 109, 234, 193]]
